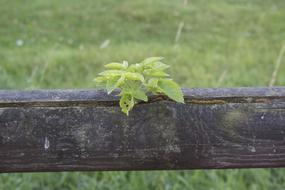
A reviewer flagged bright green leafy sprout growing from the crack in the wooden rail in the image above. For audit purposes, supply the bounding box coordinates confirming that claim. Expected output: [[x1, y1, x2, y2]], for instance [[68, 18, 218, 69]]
[[94, 57, 184, 115]]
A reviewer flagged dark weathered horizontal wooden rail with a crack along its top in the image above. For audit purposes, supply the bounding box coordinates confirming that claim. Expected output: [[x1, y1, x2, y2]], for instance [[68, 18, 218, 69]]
[[0, 87, 285, 172]]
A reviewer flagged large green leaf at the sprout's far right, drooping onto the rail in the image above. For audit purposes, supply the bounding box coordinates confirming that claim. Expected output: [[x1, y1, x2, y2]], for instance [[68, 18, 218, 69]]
[[158, 79, 184, 103]]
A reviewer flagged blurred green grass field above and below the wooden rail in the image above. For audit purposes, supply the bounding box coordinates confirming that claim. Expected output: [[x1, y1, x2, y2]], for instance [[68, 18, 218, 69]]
[[0, 0, 285, 190]]
